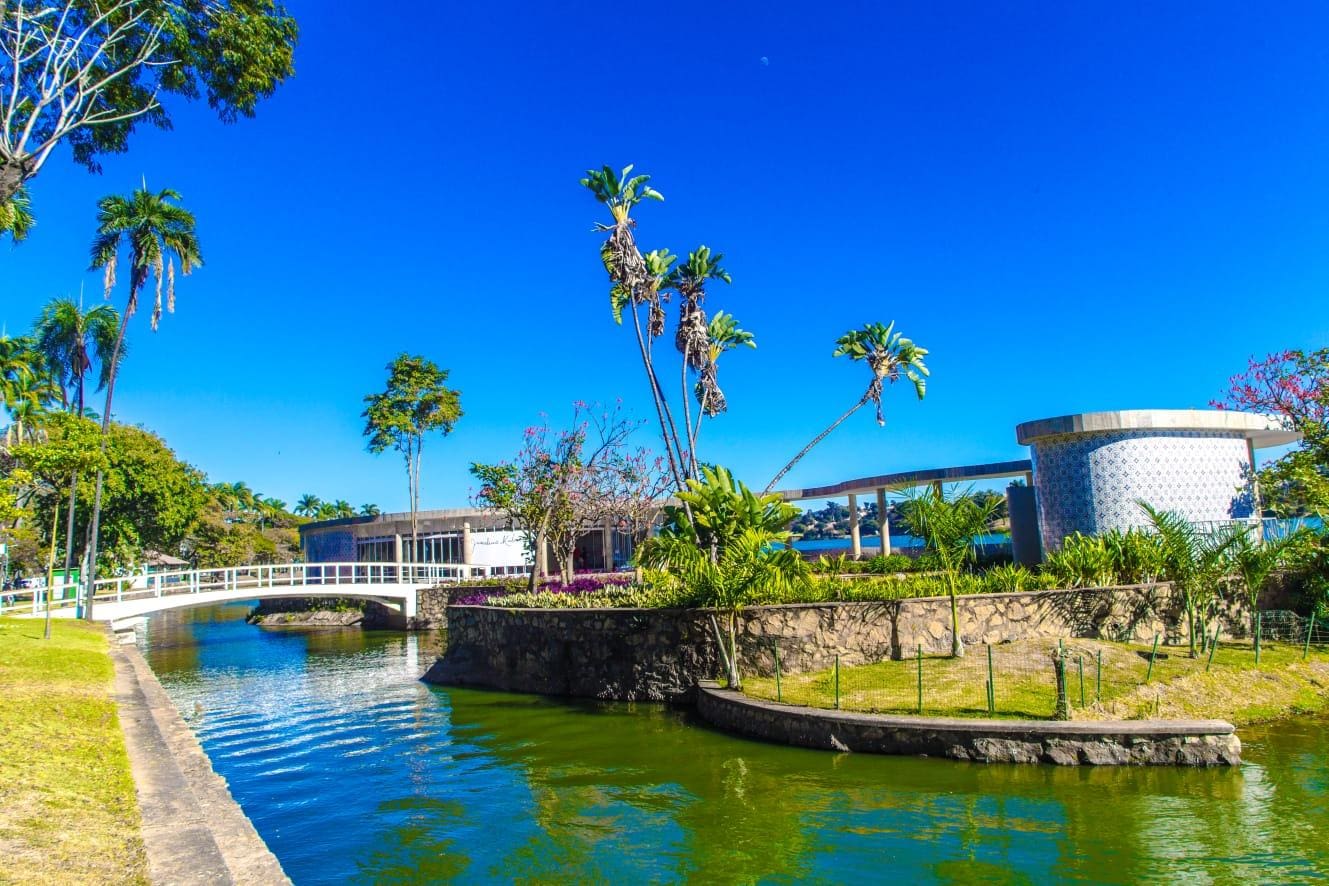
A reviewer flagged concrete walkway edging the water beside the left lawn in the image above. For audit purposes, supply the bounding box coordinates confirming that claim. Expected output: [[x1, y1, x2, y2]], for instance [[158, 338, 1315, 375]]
[[112, 640, 290, 886]]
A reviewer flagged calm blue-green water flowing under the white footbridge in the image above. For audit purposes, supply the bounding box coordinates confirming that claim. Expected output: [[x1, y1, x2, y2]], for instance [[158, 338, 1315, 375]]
[[137, 606, 1329, 883]]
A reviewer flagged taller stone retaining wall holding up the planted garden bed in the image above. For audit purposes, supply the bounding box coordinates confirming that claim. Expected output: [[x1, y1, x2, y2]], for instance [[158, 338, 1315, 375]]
[[424, 584, 1275, 701]]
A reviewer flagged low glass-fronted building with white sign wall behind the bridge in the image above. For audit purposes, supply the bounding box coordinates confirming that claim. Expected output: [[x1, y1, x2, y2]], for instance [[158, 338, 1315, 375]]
[[300, 507, 633, 575]]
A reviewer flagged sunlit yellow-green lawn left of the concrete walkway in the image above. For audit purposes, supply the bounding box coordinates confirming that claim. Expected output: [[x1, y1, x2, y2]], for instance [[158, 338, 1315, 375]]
[[0, 619, 148, 883]]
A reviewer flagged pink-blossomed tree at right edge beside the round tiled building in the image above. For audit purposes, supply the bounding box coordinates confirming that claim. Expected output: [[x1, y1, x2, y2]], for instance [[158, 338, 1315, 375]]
[[1212, 348, 1329, 517]]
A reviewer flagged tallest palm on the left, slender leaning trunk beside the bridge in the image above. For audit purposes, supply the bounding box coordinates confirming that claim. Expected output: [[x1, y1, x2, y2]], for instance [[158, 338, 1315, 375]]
[[85, 183, 203, 619]]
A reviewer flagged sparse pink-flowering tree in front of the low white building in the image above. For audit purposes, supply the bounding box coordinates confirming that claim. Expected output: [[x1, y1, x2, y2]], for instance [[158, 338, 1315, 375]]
[[470, 402, 667, 590]]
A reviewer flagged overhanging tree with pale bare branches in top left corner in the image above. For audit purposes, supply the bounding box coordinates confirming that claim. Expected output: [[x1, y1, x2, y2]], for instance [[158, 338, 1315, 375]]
[[0, 0, 298, 205]]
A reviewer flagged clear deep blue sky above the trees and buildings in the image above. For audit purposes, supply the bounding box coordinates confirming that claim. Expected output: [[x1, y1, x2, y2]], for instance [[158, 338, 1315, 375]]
[[0, 0, 1329, 510]]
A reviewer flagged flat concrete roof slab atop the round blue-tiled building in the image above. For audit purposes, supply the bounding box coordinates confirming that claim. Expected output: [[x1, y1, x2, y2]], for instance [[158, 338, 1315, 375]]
[[1015, 409, 1301, 449]]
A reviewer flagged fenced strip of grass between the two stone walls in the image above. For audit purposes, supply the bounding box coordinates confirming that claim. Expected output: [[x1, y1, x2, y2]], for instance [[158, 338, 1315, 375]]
[[743, 639, 1329, 725]]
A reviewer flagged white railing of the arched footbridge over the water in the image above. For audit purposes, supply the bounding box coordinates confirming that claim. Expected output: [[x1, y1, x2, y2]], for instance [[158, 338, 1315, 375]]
[[0, 563, 488, 615]]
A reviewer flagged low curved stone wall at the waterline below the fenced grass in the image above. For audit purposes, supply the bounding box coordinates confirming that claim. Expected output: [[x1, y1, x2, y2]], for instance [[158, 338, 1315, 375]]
[[696, 683, 1241, 766]]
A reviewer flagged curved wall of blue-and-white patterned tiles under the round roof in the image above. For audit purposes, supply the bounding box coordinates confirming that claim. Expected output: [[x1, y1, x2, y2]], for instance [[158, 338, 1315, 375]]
[[1030, 429, 1255, 550]]
